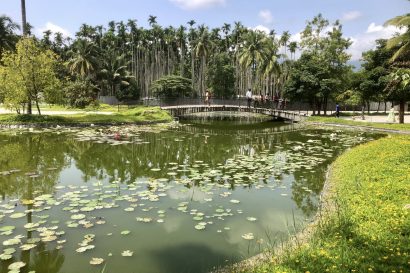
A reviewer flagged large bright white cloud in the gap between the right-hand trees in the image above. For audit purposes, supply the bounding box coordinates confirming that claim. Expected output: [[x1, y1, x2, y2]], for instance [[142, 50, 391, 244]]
[[348, 23, 404, 61]]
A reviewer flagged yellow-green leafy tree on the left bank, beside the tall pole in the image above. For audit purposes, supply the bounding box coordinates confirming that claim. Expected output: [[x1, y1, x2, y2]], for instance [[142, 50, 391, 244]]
[[0, 38, 60, 114]]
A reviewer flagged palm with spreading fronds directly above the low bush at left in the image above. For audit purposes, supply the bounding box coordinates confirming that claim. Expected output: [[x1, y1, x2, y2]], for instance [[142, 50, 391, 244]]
[[67, 39, 98, 79]]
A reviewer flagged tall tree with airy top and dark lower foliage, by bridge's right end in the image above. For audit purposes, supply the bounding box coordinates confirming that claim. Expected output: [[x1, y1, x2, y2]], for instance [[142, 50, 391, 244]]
[[285, 14, 351, 112]]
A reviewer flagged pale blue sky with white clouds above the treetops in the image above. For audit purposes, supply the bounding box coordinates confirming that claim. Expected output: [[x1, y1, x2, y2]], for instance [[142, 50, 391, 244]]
[[0, 0, 410, 61]]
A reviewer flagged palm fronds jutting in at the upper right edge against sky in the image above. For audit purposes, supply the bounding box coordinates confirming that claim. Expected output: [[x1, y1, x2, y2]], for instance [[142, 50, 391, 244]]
[[385, 13, 410, 62]]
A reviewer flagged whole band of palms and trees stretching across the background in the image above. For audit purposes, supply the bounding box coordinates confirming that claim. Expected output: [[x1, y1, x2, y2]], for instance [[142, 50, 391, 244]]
[[0, 11, 410, 120]]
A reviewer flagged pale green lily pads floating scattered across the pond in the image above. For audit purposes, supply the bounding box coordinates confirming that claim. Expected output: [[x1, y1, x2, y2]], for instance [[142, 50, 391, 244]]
[[0, 127, 372, 272]]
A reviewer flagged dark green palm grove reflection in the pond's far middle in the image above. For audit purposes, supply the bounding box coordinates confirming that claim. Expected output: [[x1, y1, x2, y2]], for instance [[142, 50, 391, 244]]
[[70, 126, 298, 182]]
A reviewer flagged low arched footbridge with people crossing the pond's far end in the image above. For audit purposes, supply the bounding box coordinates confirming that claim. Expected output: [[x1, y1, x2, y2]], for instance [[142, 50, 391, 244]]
[[161, 105, 308, 122]]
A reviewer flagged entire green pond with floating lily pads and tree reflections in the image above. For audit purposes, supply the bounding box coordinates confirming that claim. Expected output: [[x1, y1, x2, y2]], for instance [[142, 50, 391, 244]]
[[0, 121, 374, 273]]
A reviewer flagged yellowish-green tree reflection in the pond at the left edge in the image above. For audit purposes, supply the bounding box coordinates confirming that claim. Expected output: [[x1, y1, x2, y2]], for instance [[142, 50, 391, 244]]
[[0, 134, 69, 199]]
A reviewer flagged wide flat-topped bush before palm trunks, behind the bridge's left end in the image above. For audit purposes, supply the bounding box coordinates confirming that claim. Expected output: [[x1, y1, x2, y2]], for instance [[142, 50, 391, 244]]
[[151, 75, 192, 98]]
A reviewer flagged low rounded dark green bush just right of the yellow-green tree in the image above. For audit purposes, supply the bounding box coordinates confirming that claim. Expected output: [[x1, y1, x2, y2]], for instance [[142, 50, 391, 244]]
[[64, 79, 97, 108]]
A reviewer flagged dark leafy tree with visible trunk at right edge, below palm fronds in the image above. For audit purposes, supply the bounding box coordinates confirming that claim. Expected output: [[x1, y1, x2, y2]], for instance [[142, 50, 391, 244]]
[[386, 68, 410, 123]]
